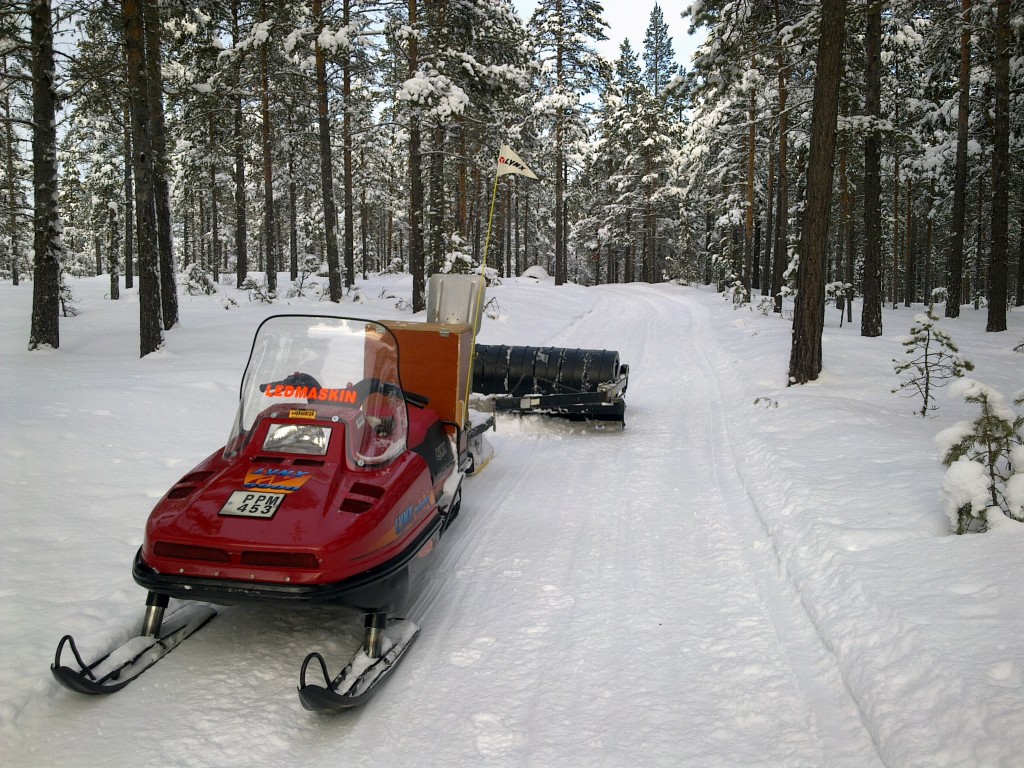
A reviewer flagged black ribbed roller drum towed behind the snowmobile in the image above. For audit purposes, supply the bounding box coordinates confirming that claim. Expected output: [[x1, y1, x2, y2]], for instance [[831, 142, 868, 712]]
[[473, 344, 620, 397]]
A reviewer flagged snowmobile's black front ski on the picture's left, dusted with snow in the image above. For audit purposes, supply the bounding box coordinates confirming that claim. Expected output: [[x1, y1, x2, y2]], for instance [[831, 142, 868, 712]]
[[50, 604, 217, 694]]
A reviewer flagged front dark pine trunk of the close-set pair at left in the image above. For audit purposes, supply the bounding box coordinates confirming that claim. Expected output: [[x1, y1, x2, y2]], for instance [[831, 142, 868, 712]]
[[122, 0, 164, 357]]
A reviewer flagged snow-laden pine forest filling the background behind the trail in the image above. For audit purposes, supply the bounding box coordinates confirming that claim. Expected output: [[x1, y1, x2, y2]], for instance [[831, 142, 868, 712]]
[[0, 0, 1024, 364]]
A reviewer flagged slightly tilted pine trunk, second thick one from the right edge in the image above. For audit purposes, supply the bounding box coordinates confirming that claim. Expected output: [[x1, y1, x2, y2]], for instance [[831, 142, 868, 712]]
[[945, 0, 971, 317]]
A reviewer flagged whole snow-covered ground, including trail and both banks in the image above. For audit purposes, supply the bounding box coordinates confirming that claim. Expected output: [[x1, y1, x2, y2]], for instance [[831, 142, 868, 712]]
[[0, 276, 1024, 768]]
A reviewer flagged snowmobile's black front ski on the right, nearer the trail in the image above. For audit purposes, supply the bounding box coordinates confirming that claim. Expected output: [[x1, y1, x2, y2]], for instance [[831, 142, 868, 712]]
[[299, 618, 420, 712]]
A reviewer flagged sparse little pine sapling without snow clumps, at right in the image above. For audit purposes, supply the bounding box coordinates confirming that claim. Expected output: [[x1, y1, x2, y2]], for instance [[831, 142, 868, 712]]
[[892, 304, 974, 417]]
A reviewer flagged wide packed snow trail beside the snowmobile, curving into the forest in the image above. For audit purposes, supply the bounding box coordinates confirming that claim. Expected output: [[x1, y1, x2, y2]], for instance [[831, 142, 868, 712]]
[[301, 287, 881, 768]]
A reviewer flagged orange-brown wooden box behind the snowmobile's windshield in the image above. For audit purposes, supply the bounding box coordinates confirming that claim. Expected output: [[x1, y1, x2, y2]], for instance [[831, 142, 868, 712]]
[[380, 321, 473, 428]]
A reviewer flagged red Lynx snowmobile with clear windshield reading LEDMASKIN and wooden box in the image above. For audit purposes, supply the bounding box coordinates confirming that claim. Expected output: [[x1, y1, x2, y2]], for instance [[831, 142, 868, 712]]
[[51, 315, 494, 710]]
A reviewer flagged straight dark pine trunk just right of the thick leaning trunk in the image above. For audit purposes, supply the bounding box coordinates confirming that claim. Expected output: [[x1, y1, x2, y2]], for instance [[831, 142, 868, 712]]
[[860, 0, 883, 338]]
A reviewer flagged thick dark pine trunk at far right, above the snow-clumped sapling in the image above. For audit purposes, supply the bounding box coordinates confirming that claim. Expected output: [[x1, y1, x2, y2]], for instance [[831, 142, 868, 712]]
[[985, 0, 1011, 333]]
